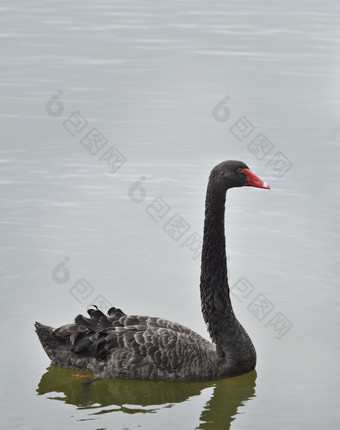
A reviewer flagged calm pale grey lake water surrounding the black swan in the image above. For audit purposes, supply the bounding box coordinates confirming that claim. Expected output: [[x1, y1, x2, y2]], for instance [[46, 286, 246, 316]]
[[0, 0, 340, 430]]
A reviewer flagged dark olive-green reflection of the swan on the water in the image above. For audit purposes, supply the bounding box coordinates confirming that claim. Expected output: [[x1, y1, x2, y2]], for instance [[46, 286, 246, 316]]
[[37, 364, 256, 430]]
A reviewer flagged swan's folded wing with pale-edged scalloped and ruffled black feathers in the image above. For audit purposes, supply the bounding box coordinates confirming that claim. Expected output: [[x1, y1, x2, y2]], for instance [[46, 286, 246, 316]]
[[54, 308, 212, 377]]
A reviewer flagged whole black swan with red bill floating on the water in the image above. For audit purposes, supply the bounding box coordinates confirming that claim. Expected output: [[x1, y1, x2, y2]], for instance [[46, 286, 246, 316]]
[[35, 160, 270, 379]]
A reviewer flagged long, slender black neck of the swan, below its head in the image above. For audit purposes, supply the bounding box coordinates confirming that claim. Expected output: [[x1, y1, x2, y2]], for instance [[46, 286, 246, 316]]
[[200, 177, 256, 371]]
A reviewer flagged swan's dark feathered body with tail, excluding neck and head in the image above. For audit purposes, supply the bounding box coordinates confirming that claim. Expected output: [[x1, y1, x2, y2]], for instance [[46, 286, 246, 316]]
[[36, 308, 221, 379]]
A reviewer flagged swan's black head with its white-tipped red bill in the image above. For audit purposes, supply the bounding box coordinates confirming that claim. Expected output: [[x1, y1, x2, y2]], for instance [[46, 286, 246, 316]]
[[211, 160, 270, 190]]
